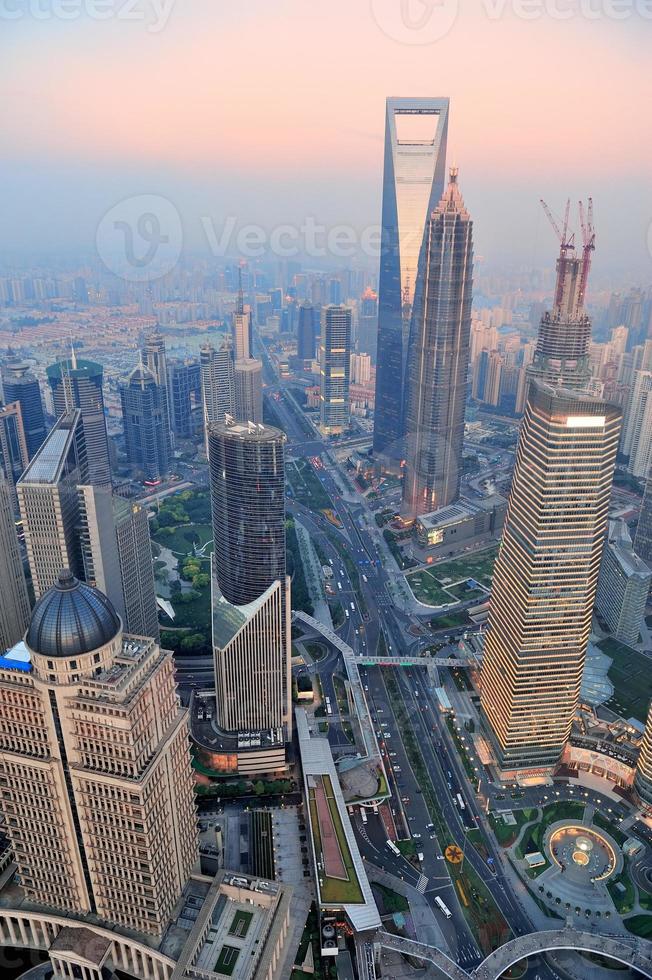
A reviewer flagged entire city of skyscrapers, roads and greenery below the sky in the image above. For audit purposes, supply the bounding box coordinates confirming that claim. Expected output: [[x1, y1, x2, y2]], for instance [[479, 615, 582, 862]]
[[0, 82, 652, 980]]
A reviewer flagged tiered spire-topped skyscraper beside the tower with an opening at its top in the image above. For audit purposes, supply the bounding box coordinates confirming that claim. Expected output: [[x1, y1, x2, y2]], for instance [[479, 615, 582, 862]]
[[401, 168, 473, 521]]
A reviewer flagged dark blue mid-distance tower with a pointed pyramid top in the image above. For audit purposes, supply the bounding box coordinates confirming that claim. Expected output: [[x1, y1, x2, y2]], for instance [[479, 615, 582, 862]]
[[120, 364, 172, 480]]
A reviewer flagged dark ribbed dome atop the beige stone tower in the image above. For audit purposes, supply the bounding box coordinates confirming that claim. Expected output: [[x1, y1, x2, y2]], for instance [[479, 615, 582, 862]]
[[25, 569, 122, 657]]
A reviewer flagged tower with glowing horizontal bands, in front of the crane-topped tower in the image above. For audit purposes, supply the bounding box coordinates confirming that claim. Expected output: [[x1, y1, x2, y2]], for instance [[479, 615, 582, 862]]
[[481, 382, 620, 772]]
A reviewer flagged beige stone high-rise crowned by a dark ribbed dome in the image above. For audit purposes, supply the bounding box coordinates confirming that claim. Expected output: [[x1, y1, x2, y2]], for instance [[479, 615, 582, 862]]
[[0, 570, 198, 936]]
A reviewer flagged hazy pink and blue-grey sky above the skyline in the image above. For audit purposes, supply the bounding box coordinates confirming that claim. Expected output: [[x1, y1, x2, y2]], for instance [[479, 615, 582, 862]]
[[0, 0, 652, 283]]
